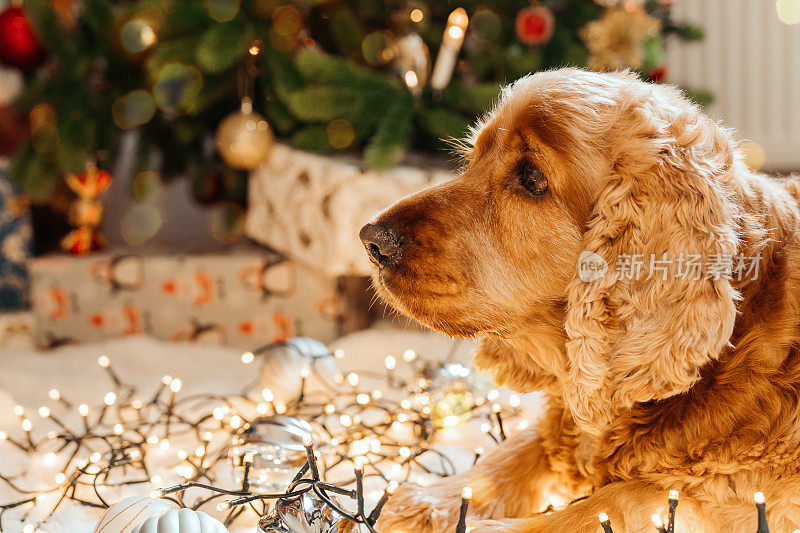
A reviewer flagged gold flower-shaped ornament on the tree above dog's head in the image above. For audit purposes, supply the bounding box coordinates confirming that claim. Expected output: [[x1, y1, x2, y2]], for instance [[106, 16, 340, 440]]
[[580, 2, 661, 70]]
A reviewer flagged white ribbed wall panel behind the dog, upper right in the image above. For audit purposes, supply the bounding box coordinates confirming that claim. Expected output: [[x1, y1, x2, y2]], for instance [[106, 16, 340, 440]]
[[667, 0, 800, 170]]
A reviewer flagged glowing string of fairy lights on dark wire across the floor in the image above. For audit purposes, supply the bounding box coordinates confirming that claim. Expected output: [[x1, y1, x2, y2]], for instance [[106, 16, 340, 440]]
[[0, 343, 780, 533]]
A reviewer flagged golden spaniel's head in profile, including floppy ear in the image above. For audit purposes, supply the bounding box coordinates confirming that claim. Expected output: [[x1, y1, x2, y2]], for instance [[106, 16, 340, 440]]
[[361, 69, 738, 429]]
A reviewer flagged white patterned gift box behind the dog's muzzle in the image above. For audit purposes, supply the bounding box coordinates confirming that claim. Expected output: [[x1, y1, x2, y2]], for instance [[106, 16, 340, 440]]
[[245, 144, 450, 276]]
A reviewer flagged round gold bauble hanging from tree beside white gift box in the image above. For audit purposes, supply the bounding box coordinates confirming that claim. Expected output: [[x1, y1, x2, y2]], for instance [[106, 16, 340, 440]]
[[217, 98, 273, 170]]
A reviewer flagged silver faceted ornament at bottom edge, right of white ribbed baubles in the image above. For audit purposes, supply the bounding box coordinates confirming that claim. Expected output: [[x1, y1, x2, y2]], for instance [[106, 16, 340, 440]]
[[258, 492, 355, 533]]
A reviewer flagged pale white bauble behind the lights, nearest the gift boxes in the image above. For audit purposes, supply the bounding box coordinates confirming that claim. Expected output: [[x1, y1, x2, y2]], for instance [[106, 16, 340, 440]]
[[259, 337, 336, 403]]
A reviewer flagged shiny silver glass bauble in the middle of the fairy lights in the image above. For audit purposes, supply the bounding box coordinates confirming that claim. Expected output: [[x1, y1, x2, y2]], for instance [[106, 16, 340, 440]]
[[231, 415, 313, 493]]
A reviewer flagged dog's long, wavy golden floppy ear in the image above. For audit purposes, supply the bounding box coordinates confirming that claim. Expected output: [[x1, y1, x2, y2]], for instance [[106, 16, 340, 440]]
[[564, 84, 738, 433]]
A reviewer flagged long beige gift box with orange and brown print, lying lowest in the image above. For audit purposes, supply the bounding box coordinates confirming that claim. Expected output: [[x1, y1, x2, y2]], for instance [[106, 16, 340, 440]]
[[30, 248, 353, 349]]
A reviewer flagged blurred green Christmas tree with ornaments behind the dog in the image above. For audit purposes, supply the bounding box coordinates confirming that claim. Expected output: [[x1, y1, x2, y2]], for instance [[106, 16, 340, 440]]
[[0, 0, 702, 201]]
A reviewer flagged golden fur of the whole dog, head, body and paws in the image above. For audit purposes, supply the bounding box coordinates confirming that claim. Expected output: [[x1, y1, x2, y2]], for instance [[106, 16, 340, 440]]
[[362, 69, 800, 533]]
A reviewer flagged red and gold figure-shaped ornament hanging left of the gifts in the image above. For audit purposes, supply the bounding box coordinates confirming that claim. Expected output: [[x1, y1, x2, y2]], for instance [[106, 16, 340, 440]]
[[61, 163, 111, 255]]
